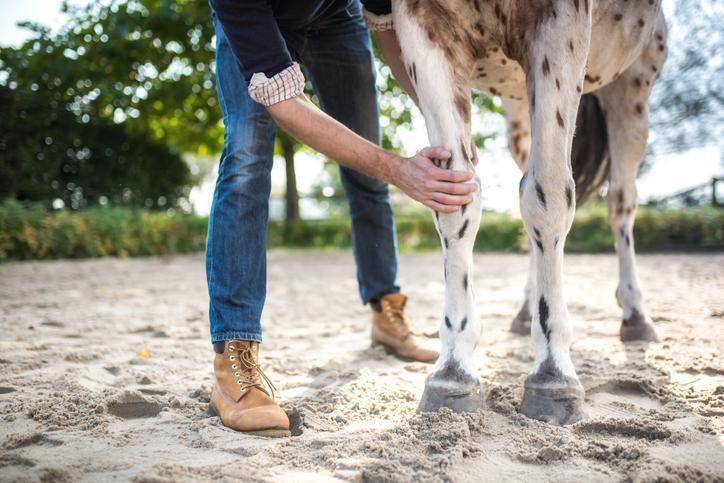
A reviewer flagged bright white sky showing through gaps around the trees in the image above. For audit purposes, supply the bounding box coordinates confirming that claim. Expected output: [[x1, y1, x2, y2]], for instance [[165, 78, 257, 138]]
[[0, 0, 724, 216]]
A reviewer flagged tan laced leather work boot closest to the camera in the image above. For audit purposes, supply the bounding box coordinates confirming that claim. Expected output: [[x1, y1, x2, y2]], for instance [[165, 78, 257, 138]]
[[210, 340, 291, 438]]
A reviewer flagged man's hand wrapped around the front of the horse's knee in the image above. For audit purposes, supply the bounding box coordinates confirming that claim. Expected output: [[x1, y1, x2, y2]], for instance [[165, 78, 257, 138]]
[[391, 148, 477, 213]]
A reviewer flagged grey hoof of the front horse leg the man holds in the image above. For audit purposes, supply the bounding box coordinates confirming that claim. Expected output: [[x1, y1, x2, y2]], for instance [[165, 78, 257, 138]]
[[417, 374, 485, 413]]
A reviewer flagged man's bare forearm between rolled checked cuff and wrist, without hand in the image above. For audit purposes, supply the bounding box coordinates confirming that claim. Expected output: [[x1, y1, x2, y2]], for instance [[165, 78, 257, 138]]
[[268, 95, 402, 183]]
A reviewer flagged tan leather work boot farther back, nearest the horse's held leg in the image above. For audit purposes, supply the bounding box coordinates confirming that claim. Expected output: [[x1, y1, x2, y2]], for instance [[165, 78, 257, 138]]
[[372, 293, 440, 362]]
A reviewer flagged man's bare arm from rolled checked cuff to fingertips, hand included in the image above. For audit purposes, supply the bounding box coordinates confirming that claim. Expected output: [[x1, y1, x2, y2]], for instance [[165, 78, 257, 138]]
[[267, 95, 476, 213]]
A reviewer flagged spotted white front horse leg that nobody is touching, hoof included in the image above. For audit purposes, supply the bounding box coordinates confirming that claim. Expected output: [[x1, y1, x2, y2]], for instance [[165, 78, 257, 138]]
[[520, 2, 591, 424]]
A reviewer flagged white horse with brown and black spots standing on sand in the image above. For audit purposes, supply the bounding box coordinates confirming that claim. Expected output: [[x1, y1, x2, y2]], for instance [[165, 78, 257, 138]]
[[392, 0, 666, 424]]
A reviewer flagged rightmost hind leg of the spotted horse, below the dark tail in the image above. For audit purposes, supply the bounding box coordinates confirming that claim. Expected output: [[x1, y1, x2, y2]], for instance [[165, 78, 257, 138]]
[[596, 24, 666, 341]]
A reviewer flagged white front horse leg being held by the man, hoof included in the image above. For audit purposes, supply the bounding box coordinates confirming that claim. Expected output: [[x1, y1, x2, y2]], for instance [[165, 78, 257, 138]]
[[393, 2, 483, 412]]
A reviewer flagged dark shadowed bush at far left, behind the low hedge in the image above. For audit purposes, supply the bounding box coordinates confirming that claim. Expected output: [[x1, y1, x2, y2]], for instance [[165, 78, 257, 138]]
[[0, 87, 190, 209]]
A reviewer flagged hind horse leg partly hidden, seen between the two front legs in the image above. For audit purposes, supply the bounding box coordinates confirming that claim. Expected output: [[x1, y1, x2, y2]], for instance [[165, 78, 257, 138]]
[[503, 99, 535, 335]]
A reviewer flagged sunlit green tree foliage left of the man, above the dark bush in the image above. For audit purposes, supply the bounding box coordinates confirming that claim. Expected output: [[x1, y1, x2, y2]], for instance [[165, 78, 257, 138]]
[[0, 0, 222, 154]]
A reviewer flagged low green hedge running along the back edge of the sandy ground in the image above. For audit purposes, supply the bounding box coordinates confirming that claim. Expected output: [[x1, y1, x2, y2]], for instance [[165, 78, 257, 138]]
[[0, 202, 724, 261]]
